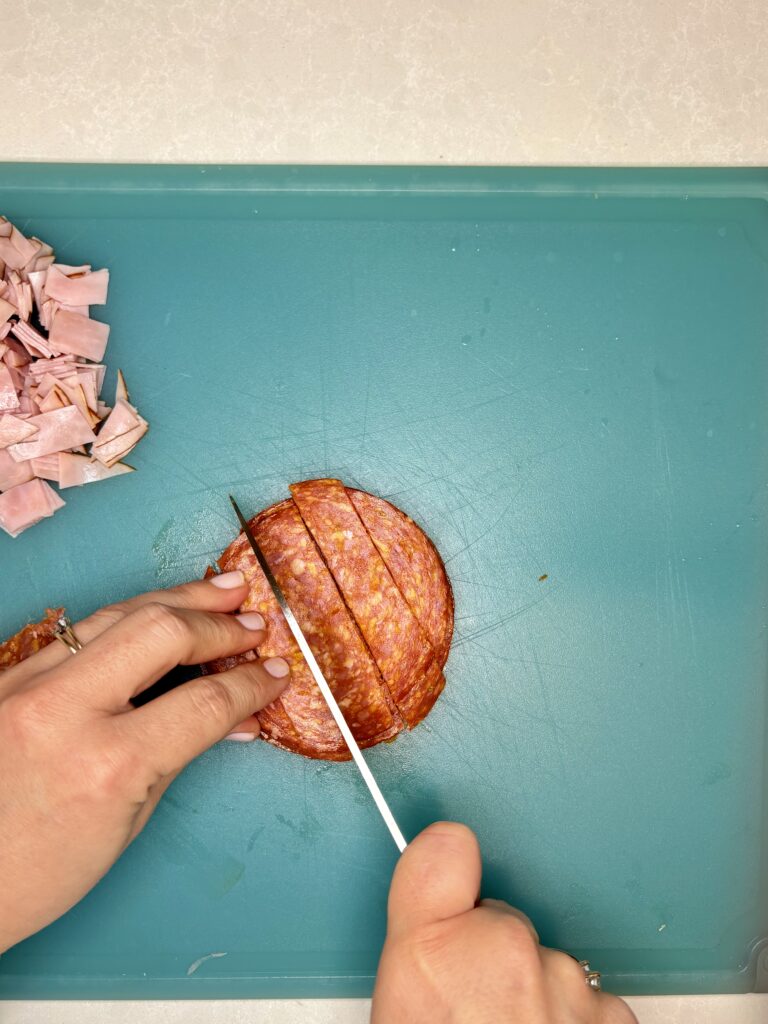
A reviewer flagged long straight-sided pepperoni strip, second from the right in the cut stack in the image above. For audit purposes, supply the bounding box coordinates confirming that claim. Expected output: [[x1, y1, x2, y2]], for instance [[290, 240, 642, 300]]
[[290, 479, 445, 727]]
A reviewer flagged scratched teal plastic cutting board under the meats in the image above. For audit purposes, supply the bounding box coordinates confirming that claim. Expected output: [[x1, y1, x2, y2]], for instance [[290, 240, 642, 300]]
[[0, 165, 768, 998]]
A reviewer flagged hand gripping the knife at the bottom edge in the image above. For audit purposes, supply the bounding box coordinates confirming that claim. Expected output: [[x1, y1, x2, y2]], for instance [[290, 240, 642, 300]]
[[371, 821, 637, 1024]]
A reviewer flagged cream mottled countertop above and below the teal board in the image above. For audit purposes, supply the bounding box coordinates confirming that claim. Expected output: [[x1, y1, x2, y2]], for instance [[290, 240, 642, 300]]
[[0, 0, 768, 1024]]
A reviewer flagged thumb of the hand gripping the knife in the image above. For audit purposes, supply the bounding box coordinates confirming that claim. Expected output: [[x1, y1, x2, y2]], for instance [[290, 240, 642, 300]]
[[388, 821, 481, 937]]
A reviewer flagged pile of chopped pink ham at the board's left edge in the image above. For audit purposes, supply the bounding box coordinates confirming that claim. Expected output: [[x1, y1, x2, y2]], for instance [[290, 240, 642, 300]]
[[0, 217, 148, 537]]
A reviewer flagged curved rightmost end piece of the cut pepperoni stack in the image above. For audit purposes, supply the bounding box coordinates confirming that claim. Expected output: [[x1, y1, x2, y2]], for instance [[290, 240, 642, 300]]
[[347, 487, 454, 667]]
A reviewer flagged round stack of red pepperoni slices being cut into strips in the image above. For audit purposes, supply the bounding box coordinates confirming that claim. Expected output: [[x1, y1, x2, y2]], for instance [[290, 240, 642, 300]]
[[208, 479, 454, 761]]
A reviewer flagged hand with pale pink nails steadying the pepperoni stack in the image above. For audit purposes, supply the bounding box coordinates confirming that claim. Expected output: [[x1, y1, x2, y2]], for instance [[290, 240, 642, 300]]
[[0, 572, 289, 951]]
